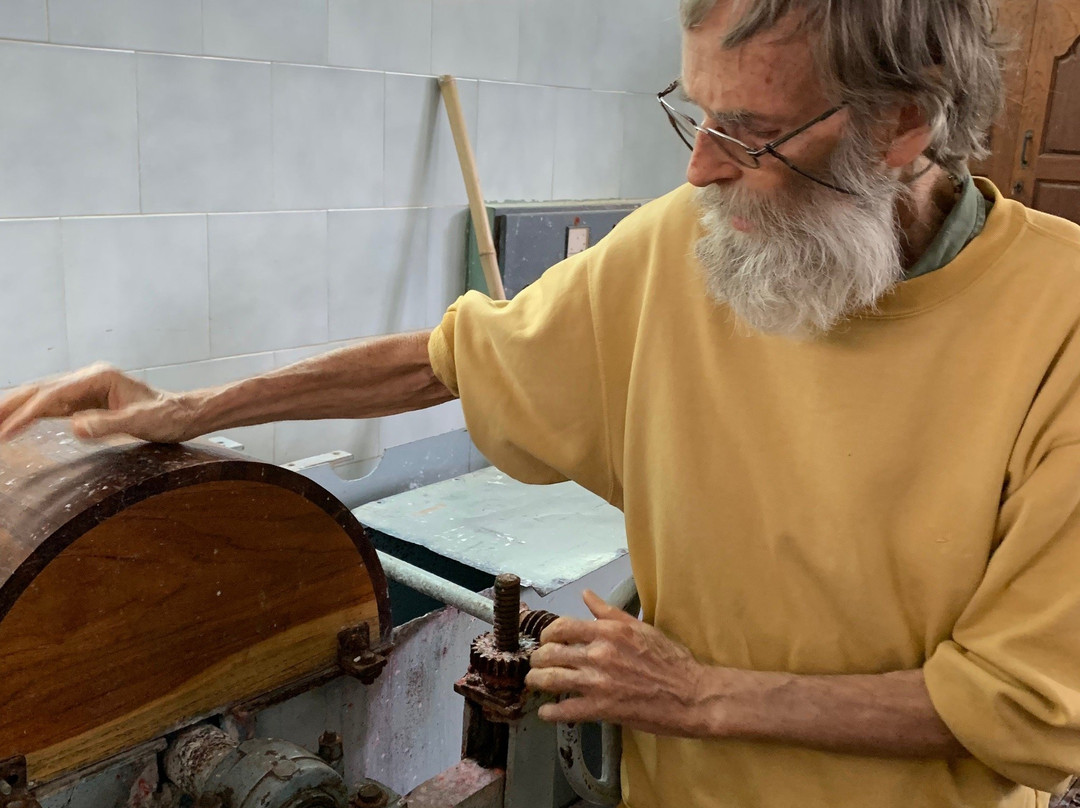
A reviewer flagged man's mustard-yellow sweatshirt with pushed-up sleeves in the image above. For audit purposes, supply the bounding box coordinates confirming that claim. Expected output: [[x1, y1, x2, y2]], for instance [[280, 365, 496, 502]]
[[430, 180, 1080, 808]]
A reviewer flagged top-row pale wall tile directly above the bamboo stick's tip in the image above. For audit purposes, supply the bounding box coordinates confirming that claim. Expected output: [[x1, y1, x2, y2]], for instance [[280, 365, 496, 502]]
[[431, 0, 521, 81]]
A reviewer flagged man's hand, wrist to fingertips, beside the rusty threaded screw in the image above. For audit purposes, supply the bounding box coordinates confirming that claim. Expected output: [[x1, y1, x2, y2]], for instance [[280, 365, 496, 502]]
[[525, 591, 707, 737]]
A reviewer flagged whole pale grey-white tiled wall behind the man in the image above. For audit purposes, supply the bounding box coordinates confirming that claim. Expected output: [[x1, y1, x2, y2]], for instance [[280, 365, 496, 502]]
[[0, 0, 688, 461]]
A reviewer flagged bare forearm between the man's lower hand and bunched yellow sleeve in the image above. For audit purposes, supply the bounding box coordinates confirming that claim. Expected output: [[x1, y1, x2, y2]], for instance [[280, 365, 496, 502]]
[[691, 668, 969, 757]]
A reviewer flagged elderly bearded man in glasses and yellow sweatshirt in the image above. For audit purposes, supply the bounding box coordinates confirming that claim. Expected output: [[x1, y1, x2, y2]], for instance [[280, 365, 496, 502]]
[[0, 0, 1080, 808]]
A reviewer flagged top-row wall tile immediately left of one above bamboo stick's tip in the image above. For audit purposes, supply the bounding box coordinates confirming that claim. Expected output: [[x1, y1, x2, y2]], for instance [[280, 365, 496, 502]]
[[329, 0, 432, 73]]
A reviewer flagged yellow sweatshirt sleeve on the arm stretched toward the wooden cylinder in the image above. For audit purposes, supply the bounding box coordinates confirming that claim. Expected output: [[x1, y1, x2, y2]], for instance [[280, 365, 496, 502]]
[[429, 251, 613, 501]]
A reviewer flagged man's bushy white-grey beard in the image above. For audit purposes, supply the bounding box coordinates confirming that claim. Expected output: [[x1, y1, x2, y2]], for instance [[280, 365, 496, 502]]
[[694, 164, 904, 337]]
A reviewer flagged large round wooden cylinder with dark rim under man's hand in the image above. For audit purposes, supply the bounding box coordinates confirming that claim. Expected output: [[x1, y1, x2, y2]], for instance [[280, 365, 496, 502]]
[[0, 421, 391, 782]]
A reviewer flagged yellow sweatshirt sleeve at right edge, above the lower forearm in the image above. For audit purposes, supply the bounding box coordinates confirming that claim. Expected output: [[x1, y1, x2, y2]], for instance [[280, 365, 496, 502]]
[[924, 332, 1080, 793]]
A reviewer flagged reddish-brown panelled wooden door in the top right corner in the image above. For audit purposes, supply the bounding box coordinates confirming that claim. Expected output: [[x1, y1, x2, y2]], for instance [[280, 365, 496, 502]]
[[1012, 0, 1080, 223]]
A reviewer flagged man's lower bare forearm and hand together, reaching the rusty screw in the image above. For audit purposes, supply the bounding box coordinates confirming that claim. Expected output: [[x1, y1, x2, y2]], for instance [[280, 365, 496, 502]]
[[525, 592, 969, 758]]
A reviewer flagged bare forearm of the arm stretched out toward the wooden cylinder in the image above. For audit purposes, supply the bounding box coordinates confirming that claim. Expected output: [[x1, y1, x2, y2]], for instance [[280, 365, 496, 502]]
[[185, 332, 454, 434]]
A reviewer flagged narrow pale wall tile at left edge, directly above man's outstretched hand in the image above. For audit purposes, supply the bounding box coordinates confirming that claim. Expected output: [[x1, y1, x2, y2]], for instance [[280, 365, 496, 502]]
[[0, 219, 68, 388]]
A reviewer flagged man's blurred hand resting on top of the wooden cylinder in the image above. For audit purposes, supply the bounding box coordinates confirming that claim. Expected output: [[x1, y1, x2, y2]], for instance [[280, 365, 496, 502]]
[[0, 364, 199, 443]]
